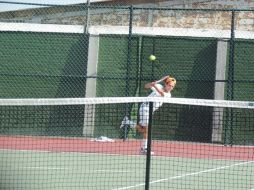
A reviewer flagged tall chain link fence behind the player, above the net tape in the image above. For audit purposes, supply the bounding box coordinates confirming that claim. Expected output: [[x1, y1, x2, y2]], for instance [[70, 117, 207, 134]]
[[0, 3, 254, 141]]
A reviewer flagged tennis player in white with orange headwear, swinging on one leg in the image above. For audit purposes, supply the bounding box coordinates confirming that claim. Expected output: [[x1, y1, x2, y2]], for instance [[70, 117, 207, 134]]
[[120, 76, 176, 154]]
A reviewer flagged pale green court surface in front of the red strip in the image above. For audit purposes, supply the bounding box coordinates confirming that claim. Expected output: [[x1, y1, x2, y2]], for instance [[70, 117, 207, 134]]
[[0, 149, 254, 190]]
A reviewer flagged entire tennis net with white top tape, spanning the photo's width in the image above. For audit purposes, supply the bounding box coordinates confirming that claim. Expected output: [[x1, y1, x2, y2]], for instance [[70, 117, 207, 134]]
[[0, 97, 254, 190]]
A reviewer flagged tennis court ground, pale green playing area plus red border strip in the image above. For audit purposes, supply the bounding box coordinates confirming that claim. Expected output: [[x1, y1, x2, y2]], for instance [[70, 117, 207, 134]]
[[0, 136, 254, 190]]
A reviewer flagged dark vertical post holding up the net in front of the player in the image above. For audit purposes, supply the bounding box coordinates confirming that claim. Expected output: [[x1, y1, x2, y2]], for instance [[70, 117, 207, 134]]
[[145, 102, 153, 190]]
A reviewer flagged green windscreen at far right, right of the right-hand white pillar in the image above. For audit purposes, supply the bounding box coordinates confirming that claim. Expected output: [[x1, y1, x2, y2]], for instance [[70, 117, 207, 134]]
[[224, 39, 254, 144]]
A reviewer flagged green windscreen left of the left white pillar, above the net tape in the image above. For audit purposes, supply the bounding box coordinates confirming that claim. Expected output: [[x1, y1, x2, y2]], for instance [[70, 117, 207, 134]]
[[0, 32, 88, 98]]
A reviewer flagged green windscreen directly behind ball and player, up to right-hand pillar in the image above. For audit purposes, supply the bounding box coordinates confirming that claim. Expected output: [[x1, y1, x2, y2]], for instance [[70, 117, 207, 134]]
[[141, 37, 217, 142]]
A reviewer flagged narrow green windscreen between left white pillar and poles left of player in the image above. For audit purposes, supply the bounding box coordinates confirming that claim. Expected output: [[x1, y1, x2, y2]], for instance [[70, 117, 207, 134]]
[[95, 35, 140, 137]]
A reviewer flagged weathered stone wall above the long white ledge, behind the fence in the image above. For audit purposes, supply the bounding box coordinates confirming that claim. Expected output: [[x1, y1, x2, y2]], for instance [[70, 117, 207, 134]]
[[0, 0, 254, 31]]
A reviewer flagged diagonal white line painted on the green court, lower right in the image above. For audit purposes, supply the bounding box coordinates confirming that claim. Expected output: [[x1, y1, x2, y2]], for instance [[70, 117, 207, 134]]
[[112, 161, 254, 190]]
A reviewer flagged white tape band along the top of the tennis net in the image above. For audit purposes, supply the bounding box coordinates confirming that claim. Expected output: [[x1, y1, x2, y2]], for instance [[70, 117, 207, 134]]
[[0, 97, 254, 109]]
